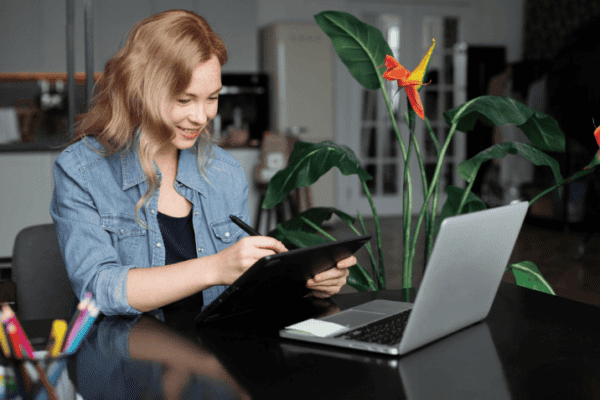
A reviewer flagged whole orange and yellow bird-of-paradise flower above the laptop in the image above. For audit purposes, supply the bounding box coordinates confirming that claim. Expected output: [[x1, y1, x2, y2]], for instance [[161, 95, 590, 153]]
[[383, 39, 435, 120]]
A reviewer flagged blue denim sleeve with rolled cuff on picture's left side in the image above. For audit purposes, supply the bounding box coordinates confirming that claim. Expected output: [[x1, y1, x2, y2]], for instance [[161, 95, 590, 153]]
[[50, 145, 142, 315]]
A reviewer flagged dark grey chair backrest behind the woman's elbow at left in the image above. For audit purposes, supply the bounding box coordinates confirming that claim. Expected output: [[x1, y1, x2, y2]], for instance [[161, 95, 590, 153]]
[[11, 224, 75, 320]]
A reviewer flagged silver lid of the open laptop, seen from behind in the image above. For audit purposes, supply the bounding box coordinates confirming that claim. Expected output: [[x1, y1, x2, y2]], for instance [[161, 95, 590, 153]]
[[399, 202, 529, 354]]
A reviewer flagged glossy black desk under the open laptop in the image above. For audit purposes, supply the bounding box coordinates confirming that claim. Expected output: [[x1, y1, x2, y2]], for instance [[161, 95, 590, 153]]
[[12, 283, 600, 399]]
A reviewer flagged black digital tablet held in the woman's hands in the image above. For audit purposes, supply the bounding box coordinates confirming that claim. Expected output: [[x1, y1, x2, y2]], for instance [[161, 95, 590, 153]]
[[195, 235, 371, 324]]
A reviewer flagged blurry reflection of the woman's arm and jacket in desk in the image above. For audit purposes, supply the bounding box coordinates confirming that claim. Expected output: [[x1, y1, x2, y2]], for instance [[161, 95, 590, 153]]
[[70, 315, 249, 399]]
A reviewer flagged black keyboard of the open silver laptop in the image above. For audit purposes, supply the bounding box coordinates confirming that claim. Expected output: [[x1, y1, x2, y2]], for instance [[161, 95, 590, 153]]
[[335, 310, 411, 345]]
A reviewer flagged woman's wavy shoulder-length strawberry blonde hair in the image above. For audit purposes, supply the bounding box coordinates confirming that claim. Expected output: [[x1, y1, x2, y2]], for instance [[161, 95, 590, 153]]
[[75, 10, 227, 226]]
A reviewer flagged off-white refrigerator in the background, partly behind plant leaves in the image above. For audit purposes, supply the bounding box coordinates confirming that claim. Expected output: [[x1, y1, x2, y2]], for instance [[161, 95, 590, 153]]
[[261, 22, 336, 207]]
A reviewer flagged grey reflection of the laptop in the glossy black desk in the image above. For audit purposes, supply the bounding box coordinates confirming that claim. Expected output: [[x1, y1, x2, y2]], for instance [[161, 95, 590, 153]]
[[280, 322, 511, 400]]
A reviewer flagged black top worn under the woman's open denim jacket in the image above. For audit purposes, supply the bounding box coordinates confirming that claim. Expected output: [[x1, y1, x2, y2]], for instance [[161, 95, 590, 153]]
[[158, 211, 204, 322]]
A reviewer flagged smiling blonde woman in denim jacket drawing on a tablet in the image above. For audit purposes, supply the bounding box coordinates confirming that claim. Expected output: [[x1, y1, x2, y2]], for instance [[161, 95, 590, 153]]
[[50, 10, 356, 322]]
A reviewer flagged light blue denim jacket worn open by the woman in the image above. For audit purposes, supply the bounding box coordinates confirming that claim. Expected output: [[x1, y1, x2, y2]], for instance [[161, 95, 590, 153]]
[[50, 138, 250, 315]]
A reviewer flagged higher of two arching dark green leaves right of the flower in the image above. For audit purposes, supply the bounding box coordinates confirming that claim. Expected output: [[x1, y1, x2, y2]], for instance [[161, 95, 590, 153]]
[[444, 96, 565, 152]]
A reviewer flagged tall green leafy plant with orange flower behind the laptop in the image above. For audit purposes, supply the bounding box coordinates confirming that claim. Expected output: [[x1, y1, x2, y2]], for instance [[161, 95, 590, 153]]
[[262, 11, 600, 294]]
